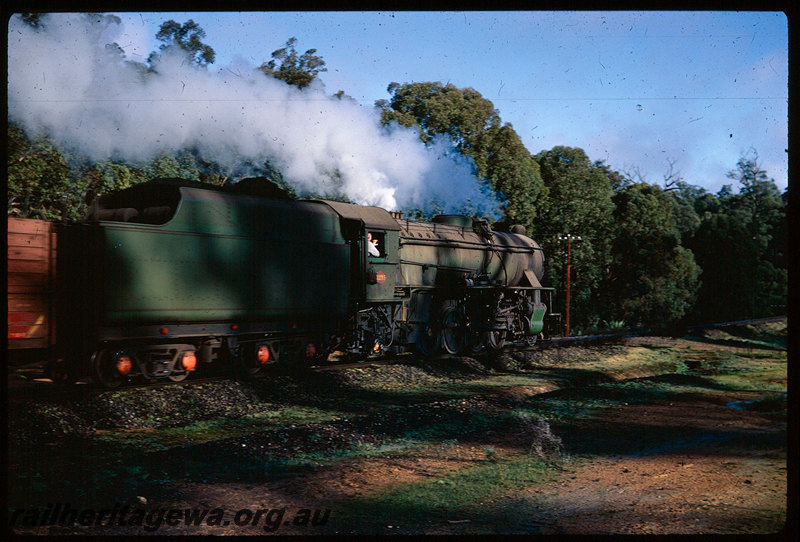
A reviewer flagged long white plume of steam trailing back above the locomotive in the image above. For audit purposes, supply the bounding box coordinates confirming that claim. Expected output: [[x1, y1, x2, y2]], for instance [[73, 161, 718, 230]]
[[8, 14, 498, 214]]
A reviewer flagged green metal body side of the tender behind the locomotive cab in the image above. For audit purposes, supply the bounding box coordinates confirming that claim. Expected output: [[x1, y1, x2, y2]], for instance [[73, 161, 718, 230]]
[[98, 187, 349, 325]]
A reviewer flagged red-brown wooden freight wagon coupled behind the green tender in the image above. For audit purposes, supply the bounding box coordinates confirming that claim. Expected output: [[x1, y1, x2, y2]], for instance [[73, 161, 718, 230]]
[[8, 217, 56, 363]]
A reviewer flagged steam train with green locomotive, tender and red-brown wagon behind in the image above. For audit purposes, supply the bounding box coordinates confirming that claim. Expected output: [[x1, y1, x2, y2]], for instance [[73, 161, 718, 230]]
[[8, 179, 553, 387]]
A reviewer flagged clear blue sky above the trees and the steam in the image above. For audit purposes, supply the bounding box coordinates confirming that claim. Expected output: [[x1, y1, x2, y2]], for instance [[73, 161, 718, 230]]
[[65, 11, 788, 196]]
